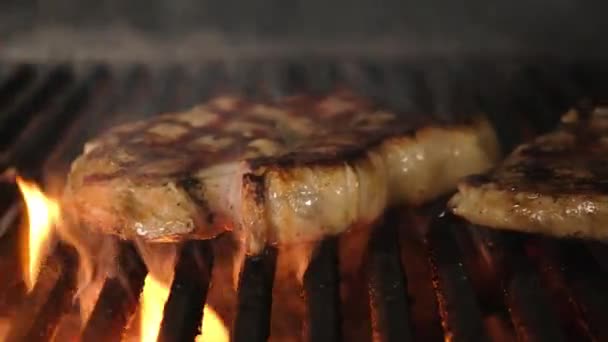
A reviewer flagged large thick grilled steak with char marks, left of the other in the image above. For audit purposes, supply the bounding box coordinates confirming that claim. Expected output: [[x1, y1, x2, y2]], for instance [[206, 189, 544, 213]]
[[65, 92, 498, 253]]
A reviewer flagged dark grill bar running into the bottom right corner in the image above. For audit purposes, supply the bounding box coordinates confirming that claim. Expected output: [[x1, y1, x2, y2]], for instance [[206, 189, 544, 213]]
[[543, 240, 608, 341]]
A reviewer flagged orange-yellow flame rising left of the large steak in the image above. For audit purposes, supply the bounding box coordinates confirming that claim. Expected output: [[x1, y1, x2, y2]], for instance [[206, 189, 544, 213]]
[[16, 176, 60, 290]]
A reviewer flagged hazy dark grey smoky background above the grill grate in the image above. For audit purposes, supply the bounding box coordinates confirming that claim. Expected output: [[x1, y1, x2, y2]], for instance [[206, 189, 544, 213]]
[[0, 0, 608, 59]]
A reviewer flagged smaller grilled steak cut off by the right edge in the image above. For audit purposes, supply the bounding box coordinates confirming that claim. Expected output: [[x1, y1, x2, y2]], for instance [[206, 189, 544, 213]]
[[449, 110, 608, 239]]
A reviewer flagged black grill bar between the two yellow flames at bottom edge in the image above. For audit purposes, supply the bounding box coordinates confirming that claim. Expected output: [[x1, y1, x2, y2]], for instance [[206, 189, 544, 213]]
[[158, 241, 213, 342]]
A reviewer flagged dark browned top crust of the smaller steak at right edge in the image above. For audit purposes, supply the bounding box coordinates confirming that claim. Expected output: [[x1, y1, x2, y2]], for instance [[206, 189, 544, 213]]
[[464, 111, 608, 196]]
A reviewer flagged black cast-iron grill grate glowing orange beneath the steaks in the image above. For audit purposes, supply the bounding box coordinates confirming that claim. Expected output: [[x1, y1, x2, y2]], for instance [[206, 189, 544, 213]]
[[0, 60, 608, 342]]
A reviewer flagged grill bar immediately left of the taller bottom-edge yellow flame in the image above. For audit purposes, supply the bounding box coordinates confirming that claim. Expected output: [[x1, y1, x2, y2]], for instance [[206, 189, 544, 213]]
[[81, 242, 148, 342]]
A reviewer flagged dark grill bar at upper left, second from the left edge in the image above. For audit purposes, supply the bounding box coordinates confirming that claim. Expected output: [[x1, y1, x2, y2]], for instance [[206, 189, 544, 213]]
[[0, 65, 73, 146]]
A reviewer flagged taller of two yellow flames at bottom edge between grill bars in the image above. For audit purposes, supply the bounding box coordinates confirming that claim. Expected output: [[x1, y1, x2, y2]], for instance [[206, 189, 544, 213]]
[[139, 274, 169, 342]]
